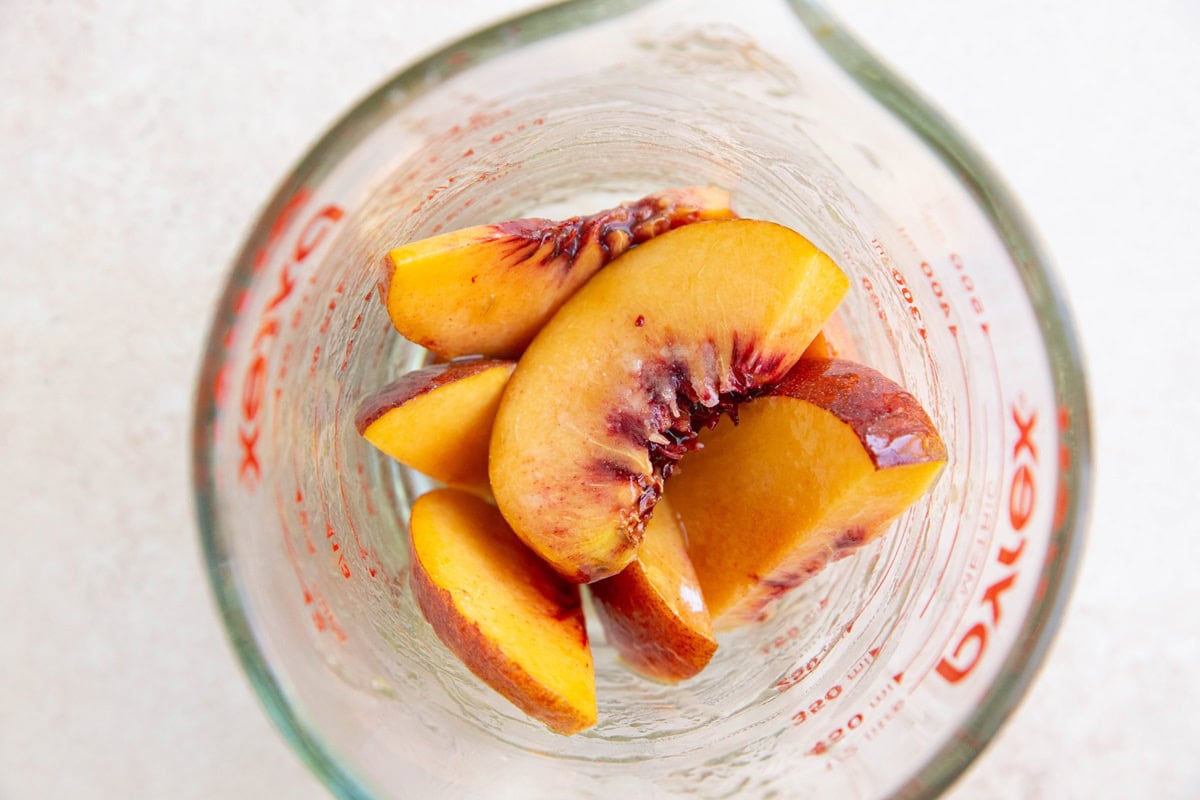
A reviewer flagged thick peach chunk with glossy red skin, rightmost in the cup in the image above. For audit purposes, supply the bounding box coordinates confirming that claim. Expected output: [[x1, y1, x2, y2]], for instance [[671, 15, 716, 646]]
[[668, 359, 946, 630]]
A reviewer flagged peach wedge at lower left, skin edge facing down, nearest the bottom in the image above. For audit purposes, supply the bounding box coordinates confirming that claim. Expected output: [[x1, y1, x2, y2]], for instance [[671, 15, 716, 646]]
[[410, 489, 596, 734]]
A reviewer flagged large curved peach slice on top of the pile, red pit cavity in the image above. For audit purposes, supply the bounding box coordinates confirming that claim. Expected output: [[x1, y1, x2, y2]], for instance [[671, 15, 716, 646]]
[[488, 219, 847, 583]]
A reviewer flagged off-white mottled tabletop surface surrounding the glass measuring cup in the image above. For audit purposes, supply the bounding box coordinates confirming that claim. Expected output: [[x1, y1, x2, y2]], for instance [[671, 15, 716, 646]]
[[0, 0, 1200, 799]]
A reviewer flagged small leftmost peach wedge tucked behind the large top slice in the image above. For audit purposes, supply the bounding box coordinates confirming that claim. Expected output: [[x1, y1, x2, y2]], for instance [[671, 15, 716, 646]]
[[354, 359, 516, 494]]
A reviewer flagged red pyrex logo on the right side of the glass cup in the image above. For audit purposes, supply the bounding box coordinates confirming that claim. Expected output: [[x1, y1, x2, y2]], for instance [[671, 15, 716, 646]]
[[937, 403, 1038, 684]]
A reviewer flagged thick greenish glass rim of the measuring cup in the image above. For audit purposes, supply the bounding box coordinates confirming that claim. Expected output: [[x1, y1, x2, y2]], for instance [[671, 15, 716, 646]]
[[191, 0, 1092, 800]]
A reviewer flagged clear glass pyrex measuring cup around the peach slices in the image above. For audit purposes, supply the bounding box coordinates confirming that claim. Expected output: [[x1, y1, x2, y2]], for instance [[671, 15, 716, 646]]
[[194, 0, 1088, 798]]
